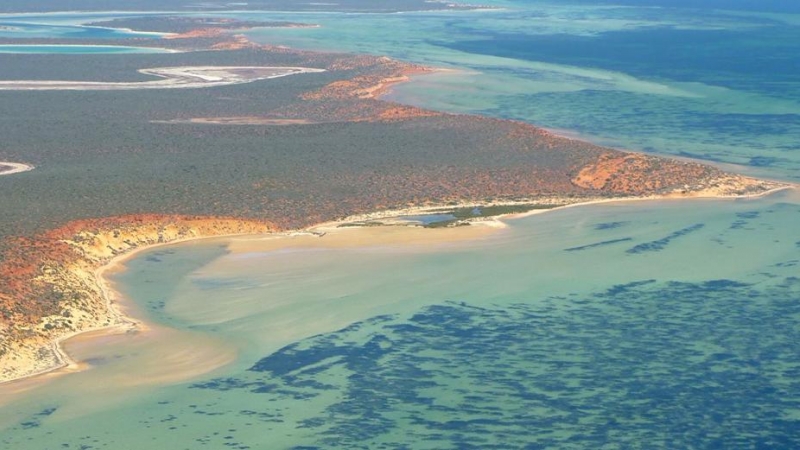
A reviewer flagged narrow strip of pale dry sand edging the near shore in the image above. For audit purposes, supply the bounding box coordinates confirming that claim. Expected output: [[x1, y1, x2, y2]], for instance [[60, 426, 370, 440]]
[[0, 184, 800, 388]]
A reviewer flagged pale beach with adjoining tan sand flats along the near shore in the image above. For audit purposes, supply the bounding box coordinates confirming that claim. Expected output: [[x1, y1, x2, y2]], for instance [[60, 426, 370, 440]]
[[0, 183, 798, 394]]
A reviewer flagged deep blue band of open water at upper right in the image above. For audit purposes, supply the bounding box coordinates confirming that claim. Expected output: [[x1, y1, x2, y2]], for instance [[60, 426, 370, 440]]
[[444, 26, 800, 98]]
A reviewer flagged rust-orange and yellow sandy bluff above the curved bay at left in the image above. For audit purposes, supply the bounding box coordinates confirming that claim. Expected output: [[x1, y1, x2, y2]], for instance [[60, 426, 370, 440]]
[[0, 215, 275, 382]]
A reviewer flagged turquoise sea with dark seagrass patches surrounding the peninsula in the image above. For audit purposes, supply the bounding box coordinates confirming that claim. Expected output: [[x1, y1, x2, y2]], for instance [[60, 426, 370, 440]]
[[0, 0, 800, 449]]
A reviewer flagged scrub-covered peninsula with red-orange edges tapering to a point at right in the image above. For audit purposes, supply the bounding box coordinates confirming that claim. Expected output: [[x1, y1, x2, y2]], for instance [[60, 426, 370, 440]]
[[0, 13, 785, 381]]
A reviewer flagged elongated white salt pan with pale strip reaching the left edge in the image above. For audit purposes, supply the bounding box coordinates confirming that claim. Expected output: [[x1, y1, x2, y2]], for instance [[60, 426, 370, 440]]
[[0, 66, 325, 91]]
